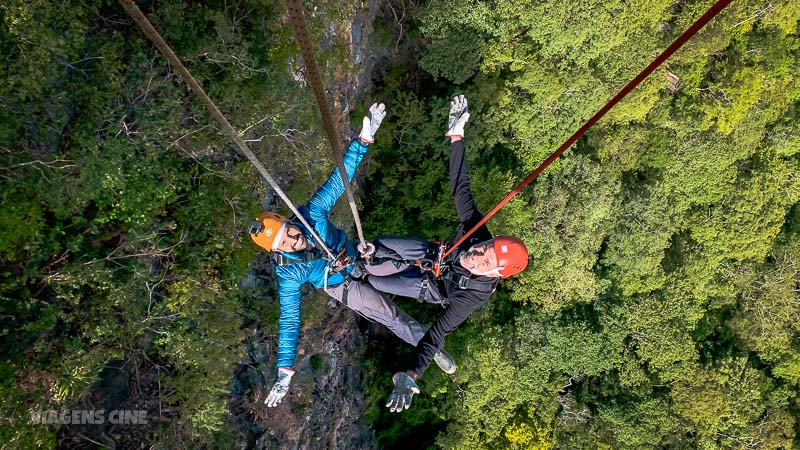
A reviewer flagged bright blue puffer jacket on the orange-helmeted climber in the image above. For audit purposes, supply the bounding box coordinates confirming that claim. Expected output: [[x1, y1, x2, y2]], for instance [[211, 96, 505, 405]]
[[275, 139, 367, 368]]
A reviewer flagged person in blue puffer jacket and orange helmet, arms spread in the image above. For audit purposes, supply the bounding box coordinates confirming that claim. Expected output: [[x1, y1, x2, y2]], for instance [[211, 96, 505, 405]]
[[250, 104, 455, 407]]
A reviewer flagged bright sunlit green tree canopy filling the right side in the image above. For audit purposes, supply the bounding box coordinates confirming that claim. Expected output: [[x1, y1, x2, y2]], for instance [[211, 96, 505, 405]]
[[365, 0, 800, 449]]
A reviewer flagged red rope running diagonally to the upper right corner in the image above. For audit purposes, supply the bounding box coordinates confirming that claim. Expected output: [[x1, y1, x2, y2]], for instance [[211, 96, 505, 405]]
[[444, 0, 731, 257]]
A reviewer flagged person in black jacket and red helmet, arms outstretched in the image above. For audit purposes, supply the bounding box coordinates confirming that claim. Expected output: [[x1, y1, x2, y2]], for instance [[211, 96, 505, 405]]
[[365, 95, 528, 412]]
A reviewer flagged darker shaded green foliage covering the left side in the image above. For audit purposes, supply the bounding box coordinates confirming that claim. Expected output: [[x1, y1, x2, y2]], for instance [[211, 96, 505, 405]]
[[0, 0, 328, 448]]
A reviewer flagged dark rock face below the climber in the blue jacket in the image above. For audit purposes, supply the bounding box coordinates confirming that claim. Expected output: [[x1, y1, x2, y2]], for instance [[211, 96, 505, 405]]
[[232, 280, 376, 449]]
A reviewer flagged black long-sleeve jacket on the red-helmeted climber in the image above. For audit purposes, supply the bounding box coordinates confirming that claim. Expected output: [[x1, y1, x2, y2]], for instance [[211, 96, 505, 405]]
[[412, 141, 500, 376]]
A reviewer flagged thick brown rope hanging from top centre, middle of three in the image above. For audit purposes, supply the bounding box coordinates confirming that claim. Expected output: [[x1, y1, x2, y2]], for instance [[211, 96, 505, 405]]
[[286, 0, 366, 248]]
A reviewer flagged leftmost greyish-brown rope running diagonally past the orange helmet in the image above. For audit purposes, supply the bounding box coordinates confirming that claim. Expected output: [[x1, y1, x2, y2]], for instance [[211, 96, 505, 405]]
[[119, 0, 338, 261]]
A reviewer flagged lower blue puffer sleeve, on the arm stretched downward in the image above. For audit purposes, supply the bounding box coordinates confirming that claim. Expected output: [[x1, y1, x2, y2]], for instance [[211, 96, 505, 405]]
[[276, 266, 303, 368]]
